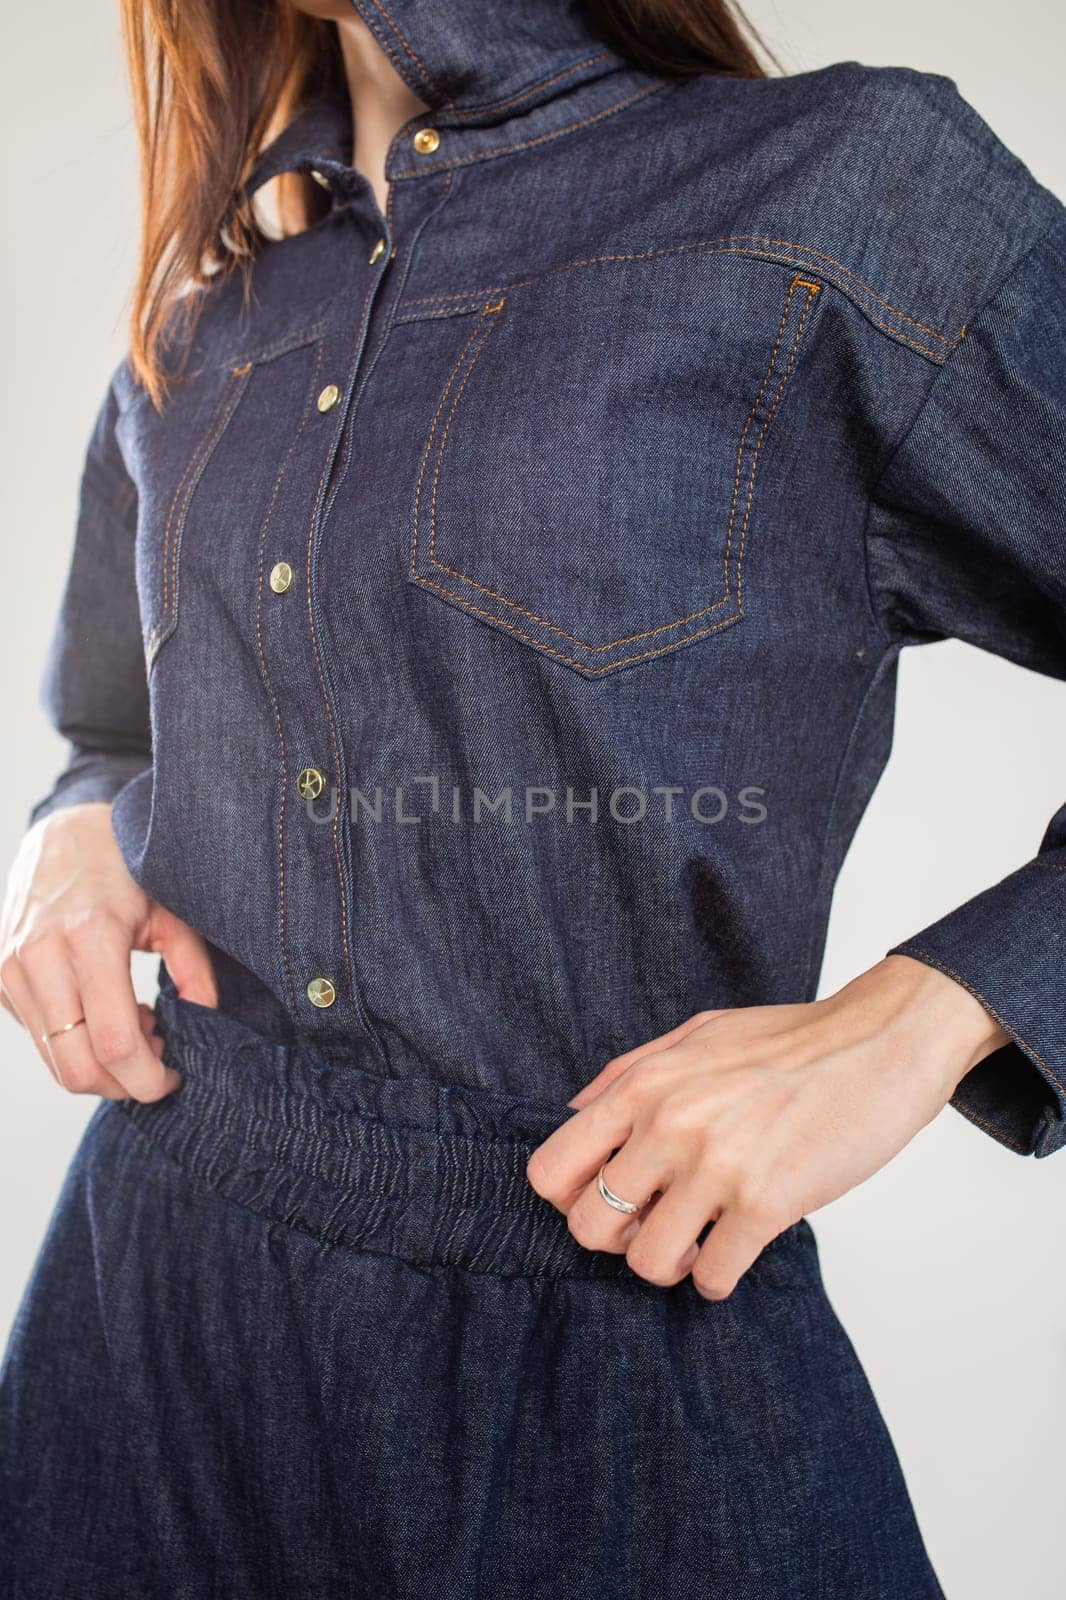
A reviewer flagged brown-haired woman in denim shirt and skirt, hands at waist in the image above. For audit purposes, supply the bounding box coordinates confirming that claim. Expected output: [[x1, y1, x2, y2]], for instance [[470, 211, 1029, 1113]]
[[0, 0, 1066, 1600]]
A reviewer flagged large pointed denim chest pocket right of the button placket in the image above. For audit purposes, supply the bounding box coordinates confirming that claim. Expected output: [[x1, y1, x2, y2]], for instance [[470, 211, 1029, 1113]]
[[410, 250, 821, 677]]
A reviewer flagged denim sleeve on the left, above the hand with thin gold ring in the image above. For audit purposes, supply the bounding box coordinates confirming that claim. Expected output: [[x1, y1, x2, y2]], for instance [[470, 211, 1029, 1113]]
[[29, 364, 152, 822]]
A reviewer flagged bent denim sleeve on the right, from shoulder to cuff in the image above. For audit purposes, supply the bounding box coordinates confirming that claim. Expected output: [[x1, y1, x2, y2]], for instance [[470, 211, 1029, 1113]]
[[868, 208, 1066, 1155]]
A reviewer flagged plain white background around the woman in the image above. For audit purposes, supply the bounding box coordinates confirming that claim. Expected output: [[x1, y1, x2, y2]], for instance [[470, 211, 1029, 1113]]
[[0, 0, 1066, 1600]]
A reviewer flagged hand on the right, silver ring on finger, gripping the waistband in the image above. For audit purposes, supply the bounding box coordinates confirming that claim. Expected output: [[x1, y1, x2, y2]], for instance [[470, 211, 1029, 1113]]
[[527, 955, 1008, 1299]]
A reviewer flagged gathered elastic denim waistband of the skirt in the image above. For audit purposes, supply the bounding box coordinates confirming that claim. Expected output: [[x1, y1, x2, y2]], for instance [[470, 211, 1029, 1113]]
[[115, 994, 807, 1288]]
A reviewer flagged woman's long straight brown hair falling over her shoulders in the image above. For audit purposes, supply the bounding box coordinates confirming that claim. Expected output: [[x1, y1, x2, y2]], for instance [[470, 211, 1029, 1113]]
[[122, 0, 776, 406]]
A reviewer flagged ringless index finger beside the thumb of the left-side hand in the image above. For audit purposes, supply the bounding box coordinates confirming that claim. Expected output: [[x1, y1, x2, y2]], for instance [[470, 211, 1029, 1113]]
[[72, 922, 181, 1101]]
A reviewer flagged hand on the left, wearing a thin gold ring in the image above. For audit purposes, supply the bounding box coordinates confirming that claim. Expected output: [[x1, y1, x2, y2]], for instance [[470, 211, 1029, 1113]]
[[0, 802, 218, 1101]]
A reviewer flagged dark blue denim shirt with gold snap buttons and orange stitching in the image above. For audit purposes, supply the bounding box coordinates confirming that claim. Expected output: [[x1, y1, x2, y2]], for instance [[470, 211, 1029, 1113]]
[[22, 9, 1066, 1155]]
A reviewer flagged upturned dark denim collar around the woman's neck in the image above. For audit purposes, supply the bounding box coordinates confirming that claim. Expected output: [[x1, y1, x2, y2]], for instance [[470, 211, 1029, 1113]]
[[242, 0, 667, 195]]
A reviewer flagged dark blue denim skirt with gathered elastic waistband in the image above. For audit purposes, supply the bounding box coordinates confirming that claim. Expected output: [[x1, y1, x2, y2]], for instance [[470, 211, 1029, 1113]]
[[0, 995, 943, 1600]]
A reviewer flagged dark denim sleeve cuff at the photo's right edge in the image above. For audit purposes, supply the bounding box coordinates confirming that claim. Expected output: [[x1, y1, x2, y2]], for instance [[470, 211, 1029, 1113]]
[[888, 851, 1066, 1155]]
